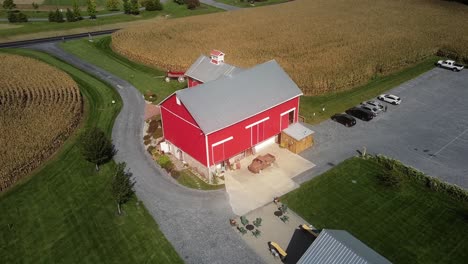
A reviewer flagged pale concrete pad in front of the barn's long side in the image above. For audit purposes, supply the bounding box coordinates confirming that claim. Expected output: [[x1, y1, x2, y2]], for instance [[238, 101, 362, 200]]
[[225, 144, 315, 215]]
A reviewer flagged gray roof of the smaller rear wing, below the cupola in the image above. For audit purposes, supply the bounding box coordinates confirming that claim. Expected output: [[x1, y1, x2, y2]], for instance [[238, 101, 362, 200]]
[[185, 55, 242, 83]]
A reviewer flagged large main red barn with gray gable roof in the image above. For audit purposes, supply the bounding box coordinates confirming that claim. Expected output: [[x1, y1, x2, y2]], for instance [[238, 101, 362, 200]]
[[160, 60, 302, 182]]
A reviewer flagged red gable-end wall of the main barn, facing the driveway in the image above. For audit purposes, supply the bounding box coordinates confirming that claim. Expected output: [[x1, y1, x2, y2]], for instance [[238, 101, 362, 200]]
[[161, 95, 206, 164]]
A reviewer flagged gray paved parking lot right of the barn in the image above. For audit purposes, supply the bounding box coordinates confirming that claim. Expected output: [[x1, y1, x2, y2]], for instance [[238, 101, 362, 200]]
[[294, 68, 468, 188]]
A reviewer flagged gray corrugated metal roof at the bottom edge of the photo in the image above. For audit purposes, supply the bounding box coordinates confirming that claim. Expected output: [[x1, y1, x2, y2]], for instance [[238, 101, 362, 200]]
[[297, 229, 391, 264]]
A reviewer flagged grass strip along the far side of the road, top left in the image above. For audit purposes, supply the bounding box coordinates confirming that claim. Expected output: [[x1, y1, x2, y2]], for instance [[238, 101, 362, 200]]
[[0, 1, 220, 41]]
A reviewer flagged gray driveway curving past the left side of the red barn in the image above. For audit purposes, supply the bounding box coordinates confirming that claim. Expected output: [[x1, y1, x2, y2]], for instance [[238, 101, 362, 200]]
[[30, 43, 263, 264]]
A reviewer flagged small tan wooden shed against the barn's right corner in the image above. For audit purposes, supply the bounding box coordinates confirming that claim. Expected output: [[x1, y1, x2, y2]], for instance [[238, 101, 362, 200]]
[[280, 123, 314, 154]]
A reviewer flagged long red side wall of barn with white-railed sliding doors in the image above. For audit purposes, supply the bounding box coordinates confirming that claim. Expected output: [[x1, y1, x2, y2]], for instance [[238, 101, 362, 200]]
[[204, 97, 299, 165]]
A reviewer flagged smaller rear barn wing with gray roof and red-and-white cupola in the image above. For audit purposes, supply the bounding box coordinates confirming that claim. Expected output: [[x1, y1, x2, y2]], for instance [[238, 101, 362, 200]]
[[185, 50, 242, 88]]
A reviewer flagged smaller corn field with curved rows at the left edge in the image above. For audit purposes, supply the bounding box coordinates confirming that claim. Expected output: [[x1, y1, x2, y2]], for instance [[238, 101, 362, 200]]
[[0, 54, 83, 191]]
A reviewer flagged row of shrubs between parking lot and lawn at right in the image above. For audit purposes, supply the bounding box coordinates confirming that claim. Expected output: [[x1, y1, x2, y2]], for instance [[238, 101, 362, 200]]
[[366, 155, 468, 201]]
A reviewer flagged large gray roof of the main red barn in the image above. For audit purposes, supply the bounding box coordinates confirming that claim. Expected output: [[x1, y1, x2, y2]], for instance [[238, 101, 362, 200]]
[[176, 60, 302, 134]]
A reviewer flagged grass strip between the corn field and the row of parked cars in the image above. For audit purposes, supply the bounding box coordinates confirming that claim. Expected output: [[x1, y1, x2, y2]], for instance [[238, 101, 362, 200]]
[[299, 57, 439, 124]]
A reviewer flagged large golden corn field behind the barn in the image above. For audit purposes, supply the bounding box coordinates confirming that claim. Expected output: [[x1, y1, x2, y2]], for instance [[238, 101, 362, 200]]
[[112, 0, 468, 95]]
